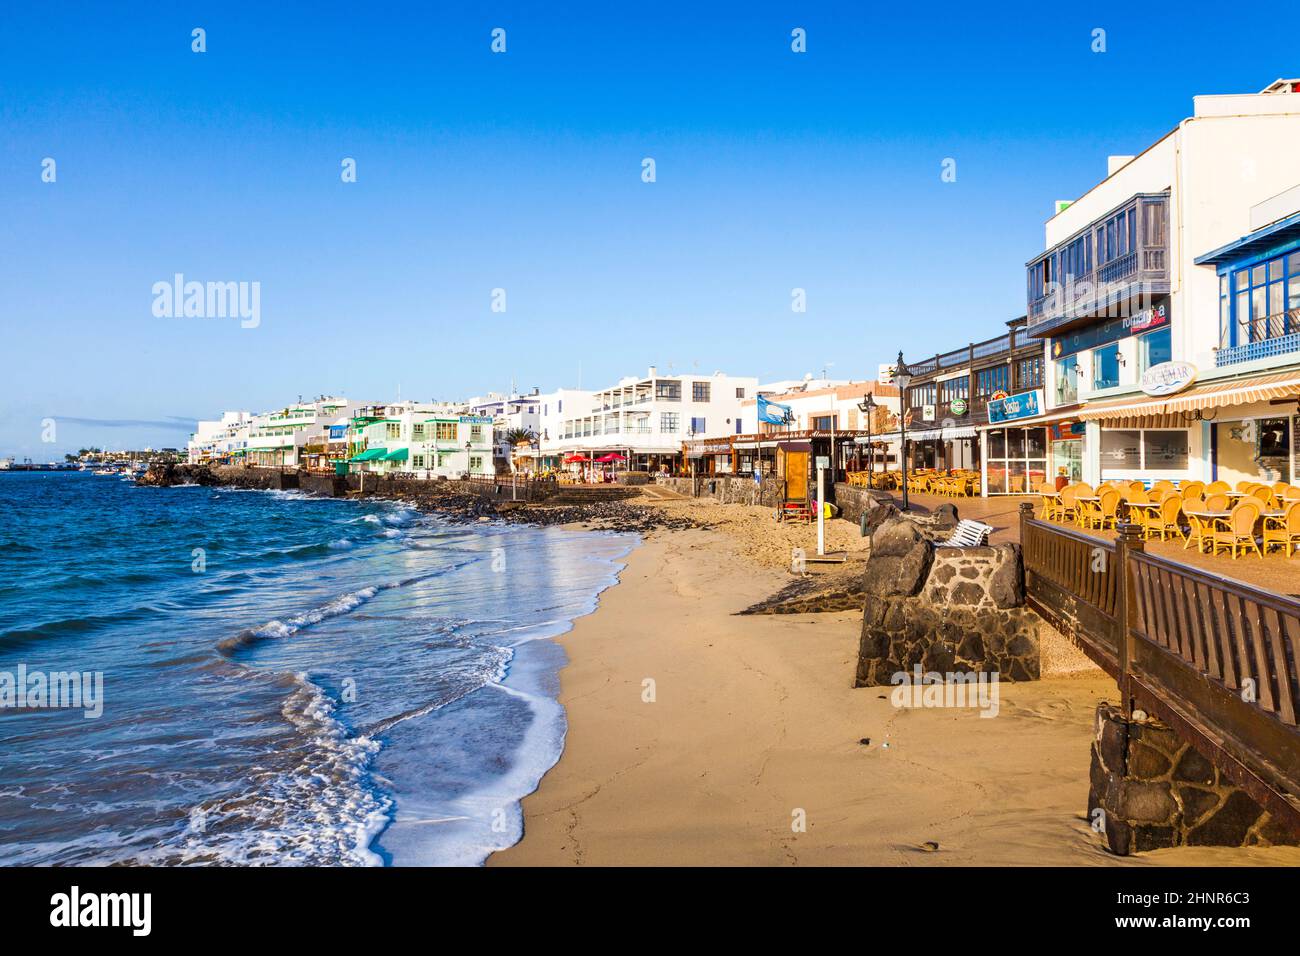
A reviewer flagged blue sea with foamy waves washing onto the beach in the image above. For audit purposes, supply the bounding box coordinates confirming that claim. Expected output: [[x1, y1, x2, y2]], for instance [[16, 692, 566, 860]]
[[0, 473, 636, 865]]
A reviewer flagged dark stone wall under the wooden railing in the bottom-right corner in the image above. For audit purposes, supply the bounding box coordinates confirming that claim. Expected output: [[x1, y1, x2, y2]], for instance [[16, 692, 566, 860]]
[[1088, 704, 1300, 855]]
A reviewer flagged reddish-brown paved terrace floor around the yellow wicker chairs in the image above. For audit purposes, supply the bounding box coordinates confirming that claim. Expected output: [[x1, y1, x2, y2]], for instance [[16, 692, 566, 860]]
[[873, 492, 1300, 598]]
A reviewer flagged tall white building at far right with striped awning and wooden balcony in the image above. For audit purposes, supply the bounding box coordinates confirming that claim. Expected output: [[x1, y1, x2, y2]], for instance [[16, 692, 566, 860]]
[[1013, 81, 1300, 484]]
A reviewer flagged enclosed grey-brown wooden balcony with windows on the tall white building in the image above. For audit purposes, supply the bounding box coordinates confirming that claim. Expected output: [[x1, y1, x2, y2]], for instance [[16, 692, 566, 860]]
[[1026, 193, 1169, 336]]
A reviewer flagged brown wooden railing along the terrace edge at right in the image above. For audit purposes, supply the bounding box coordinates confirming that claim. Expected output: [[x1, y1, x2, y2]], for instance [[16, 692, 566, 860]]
[[1021, 505, 1300, 829]]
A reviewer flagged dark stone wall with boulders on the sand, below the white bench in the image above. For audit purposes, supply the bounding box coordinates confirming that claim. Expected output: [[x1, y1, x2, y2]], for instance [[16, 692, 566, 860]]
[[854, 507, 1045, 687]]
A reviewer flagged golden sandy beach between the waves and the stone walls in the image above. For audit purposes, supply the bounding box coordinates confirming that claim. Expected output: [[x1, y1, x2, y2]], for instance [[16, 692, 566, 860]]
[[489, 506, 1300, 866]]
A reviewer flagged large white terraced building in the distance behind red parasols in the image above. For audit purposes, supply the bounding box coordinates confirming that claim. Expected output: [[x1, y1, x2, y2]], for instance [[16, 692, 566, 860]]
[[542, 365, 758, 471]]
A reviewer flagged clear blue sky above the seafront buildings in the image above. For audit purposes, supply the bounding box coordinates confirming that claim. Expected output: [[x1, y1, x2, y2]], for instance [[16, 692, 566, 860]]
[[0, 3, 1300, 460]]
